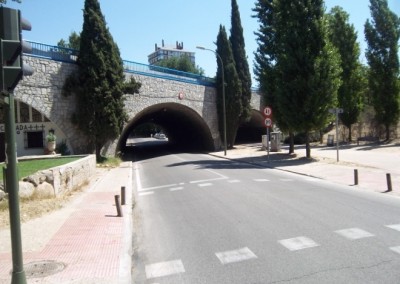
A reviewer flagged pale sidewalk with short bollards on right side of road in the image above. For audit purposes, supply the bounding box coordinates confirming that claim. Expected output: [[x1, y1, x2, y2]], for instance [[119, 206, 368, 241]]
[[213, 143, 400, 196]]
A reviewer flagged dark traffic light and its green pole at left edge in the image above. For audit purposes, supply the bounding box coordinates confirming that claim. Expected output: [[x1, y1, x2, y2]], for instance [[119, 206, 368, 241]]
[[0, 7, 33, 284]]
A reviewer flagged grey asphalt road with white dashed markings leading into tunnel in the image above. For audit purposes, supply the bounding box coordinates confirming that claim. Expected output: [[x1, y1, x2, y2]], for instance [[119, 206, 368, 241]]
[[133, 150, 400, 284]]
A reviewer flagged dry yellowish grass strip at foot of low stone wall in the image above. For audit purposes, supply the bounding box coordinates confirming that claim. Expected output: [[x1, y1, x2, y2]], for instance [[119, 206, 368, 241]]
[[0, 182, 89, 228]]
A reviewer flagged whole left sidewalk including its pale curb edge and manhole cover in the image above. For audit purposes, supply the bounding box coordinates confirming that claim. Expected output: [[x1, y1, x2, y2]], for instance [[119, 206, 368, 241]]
[[0, 162, 132, 284]]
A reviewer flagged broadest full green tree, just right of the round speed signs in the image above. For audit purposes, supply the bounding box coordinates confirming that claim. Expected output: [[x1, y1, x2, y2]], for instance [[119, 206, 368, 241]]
[[274, 0, 340, 158]]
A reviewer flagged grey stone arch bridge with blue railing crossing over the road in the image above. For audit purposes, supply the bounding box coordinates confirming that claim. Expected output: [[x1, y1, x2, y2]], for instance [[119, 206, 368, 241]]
[[5, 42, 263, 158]]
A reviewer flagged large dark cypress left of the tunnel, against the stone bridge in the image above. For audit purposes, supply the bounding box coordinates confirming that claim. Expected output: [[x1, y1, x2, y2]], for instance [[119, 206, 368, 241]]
[[69, 0, 127, 159]]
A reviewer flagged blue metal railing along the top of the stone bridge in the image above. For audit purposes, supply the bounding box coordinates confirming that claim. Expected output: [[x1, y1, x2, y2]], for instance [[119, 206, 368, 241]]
[[28, 41, 215, 86]]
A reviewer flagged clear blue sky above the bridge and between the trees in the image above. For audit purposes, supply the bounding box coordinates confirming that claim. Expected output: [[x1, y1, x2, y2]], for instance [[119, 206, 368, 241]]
[[5, 0, 400, 85]]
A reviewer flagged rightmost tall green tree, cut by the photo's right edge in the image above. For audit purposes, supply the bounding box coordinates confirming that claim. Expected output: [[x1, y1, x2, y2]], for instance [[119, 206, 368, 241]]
[[365, 0, 400, 140]]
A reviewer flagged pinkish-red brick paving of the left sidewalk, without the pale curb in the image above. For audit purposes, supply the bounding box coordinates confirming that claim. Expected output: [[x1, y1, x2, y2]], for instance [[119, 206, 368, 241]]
[[0, 162, 131, 283]]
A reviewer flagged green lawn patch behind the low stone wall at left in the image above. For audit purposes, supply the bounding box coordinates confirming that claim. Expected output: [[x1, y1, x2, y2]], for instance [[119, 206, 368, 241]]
[[0, 157, 81, 181]]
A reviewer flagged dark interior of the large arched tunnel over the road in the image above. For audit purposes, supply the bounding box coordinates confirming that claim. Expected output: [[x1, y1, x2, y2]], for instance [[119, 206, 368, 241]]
[[117, 103, 214, 154]]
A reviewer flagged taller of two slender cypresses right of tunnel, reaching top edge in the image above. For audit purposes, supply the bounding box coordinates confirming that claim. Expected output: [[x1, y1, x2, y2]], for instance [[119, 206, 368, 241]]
[[229, 0, 251, 122]]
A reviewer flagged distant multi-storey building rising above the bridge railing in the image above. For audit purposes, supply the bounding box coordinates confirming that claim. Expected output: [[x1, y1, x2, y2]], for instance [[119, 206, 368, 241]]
[[148, 40, 196, 66]]
